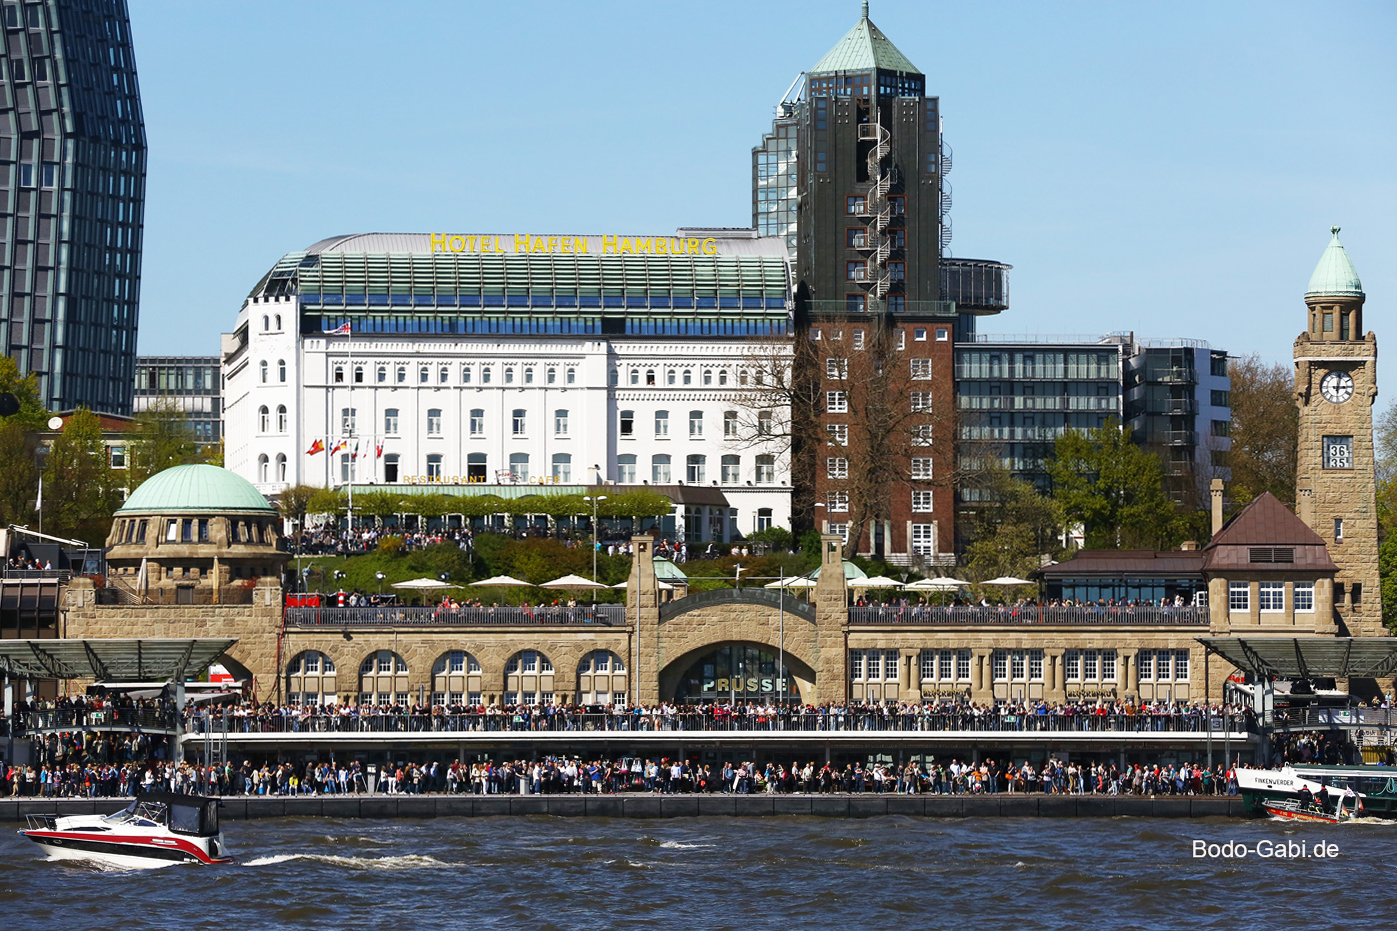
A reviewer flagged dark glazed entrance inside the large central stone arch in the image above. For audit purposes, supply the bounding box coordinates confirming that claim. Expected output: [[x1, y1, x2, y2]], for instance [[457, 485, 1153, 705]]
[[659, 640, 816, 705]]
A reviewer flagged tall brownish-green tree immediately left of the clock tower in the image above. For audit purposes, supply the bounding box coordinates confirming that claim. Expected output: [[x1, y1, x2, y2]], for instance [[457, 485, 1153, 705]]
[[1228, 354, 1299, 509]]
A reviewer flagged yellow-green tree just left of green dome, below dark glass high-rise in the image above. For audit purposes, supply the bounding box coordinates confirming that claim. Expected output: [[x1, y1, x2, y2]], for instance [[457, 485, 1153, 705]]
[[43, 408, 122, 544]]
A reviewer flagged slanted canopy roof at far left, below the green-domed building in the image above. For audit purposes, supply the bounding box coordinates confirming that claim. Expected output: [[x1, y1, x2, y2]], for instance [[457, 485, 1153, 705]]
[[0, 637, 237, 682]]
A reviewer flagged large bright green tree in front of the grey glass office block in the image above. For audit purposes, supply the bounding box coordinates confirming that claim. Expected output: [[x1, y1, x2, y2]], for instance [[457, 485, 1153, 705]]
[[1046, 418, 1176, 549]]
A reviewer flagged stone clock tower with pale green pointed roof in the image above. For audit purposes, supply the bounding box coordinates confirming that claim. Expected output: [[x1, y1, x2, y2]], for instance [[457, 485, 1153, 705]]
[[1295, 226, 1384, 636]]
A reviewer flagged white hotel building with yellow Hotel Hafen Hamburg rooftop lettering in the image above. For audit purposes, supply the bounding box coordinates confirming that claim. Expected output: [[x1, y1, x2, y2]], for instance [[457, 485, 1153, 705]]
[[222, 229, 791, 542]]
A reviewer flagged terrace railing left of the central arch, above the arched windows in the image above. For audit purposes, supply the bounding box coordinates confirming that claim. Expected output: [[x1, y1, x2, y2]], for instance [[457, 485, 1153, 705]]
[[286, 604, 626, 628]]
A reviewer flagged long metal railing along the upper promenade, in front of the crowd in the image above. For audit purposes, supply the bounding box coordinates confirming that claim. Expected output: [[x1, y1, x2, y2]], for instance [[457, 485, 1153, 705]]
[[186, 709, 1256, 735]]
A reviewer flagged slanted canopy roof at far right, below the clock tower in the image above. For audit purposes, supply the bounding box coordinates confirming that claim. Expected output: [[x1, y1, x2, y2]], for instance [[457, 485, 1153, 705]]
[[1197, 636, 1397, 679]]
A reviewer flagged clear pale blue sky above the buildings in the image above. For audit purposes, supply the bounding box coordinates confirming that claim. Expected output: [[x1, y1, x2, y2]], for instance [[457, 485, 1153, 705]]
[[130, 0, 1397, 383]]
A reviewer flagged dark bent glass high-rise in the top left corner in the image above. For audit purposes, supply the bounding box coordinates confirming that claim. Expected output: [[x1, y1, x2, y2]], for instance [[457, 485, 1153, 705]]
[[0, 0, 145, 414]]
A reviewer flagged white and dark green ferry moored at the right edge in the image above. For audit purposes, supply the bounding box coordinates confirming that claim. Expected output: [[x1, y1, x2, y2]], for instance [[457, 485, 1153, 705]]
[[1236, 763, 1397, 822]]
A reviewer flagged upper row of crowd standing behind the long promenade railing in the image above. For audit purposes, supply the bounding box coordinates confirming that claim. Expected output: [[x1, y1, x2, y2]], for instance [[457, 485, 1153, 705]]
[[186, 699, 1256, 732]]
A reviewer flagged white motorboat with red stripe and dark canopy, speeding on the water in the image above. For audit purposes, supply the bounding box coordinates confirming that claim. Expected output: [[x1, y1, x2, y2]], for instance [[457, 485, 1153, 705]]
[[20, 793, 232, 869]]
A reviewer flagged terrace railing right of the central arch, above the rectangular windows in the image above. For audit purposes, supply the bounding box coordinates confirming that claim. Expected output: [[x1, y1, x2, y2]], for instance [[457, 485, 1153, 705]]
[[849, 604, 1208, 626]]
